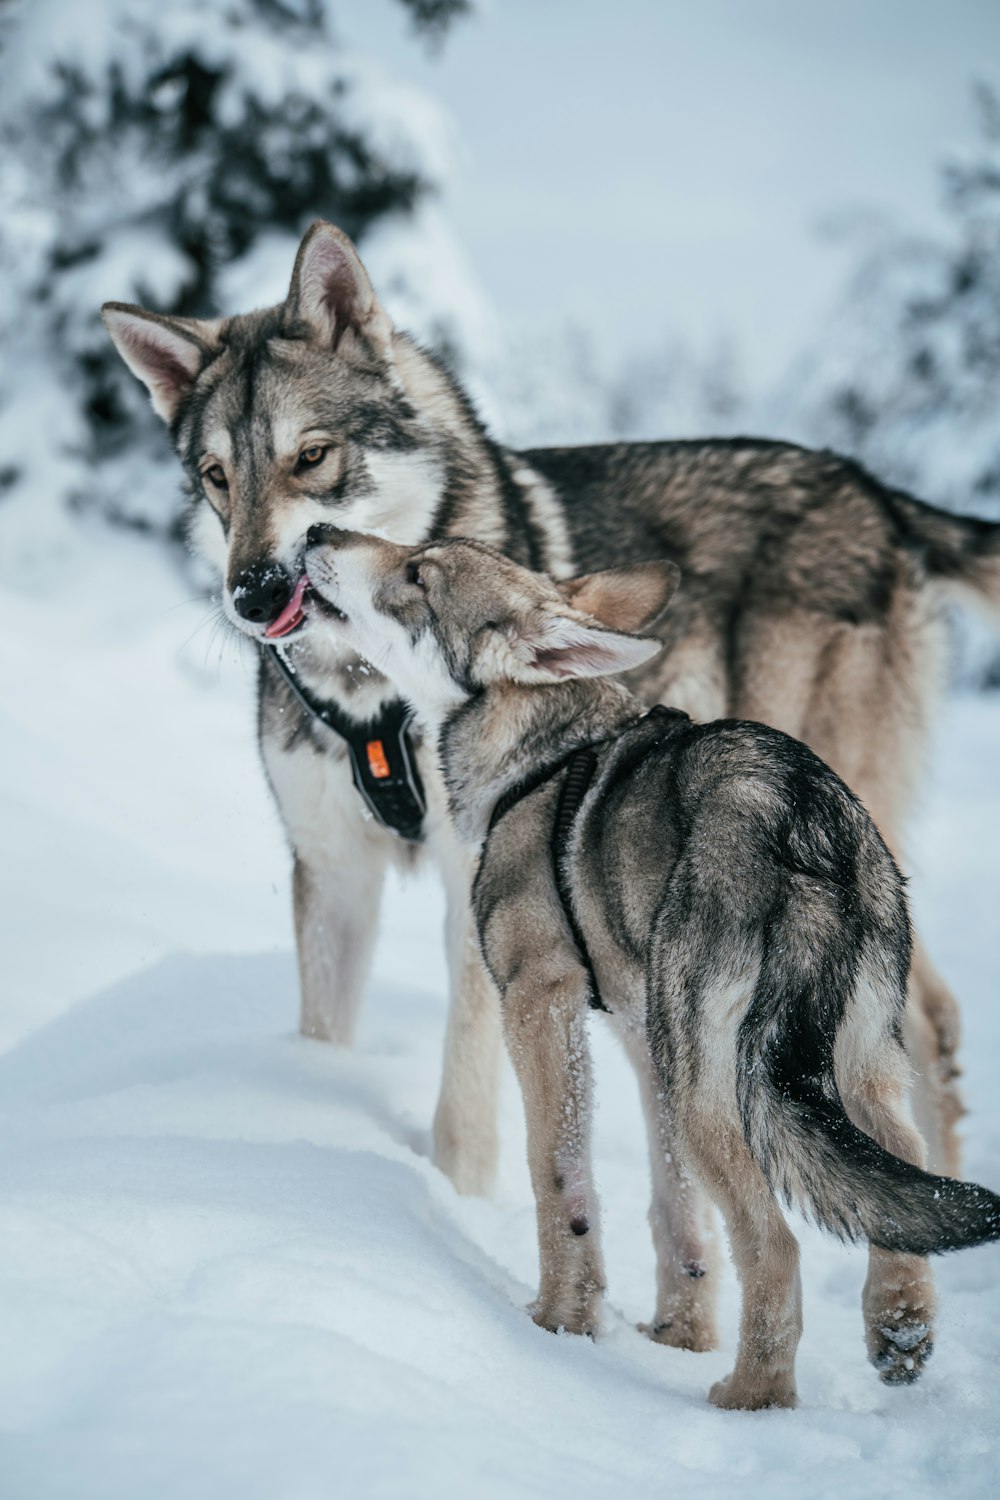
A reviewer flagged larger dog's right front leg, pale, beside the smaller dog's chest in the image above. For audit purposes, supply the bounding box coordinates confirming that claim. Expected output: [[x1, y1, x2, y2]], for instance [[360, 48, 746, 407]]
[[433, 842, 504, 1194]]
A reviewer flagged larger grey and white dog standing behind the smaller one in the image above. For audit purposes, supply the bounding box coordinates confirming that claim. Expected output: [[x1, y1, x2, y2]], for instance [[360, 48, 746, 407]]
[[103, 222, 1000, 1374]]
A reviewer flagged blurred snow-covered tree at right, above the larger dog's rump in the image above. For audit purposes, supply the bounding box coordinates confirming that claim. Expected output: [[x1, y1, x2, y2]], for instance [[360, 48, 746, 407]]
[[789, 84, 1000, 513]]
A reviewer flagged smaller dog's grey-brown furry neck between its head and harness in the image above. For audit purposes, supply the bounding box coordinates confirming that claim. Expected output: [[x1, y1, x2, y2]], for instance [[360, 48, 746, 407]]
[[438, 678, 645, 846]]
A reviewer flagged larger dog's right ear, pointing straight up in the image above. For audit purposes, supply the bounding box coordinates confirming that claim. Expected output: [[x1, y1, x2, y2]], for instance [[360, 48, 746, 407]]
[[285, 219, 393, 359]]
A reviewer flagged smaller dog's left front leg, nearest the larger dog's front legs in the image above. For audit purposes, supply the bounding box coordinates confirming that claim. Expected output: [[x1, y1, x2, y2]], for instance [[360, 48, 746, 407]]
[[504, 968, 604, 1334]]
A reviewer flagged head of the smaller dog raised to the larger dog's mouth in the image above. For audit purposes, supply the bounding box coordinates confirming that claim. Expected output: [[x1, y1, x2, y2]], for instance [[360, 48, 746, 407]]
[[306, 525, 681, 723]]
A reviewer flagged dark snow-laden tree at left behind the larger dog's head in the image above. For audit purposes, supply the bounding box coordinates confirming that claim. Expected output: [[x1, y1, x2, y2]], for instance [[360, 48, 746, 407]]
[[0, 0, 475, 561]]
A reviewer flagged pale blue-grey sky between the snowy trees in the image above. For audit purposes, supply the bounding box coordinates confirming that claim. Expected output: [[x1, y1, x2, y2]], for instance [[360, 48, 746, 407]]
[[336, 0, 1000, 381]]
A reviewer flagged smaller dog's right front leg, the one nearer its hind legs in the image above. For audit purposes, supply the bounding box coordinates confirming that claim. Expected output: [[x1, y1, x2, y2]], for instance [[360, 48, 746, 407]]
[[616, 1026, 720, 1350]]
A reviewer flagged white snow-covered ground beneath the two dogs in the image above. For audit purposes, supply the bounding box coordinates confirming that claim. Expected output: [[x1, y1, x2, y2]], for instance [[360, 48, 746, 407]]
[[0, 522, 1000, 1500]]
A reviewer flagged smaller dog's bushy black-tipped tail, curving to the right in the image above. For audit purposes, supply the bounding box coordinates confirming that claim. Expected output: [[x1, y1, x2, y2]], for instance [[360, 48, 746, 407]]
[[736, 944, 1000, 1256]]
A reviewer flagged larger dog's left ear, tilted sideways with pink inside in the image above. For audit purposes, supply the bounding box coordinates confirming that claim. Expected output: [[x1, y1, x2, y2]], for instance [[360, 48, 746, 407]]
[[100, 302, 220, 425]]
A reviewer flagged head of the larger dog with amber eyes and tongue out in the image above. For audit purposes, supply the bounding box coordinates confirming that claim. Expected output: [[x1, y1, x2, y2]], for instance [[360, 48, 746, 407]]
[[102, 222, 442, 639]]
